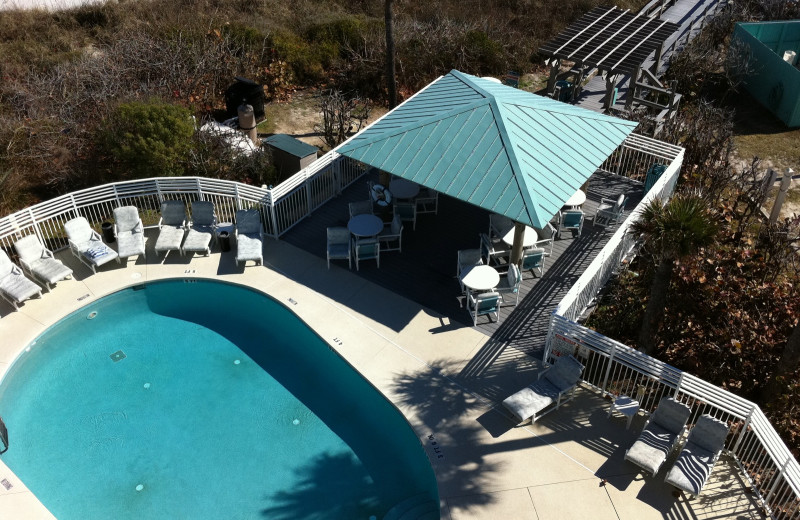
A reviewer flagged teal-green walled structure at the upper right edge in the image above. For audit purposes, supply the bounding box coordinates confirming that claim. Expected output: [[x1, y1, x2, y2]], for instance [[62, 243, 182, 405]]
[[731, 20, 800, 128]]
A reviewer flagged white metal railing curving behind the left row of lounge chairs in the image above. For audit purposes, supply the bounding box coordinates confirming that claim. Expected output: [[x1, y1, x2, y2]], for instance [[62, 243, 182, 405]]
[[0, 152, 365, 251]]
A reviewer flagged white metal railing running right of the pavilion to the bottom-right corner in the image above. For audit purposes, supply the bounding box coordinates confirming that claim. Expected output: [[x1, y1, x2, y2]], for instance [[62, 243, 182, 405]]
[[545, 141, 800, 519]]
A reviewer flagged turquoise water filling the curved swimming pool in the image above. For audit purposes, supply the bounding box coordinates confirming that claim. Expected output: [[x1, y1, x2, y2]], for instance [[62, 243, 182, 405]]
[[0, 280, 438, 520]]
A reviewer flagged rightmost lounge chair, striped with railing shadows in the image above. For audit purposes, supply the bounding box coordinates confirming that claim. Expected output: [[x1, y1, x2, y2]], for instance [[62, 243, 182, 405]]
[[664, 414, 728, 497]]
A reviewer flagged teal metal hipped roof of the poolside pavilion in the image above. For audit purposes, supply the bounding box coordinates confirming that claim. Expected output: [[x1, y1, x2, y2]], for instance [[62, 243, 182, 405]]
[[336, 70, 636, 228]]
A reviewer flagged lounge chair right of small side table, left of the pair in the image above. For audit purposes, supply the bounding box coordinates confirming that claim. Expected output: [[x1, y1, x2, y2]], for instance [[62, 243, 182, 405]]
[[625, 397, 692, 476]]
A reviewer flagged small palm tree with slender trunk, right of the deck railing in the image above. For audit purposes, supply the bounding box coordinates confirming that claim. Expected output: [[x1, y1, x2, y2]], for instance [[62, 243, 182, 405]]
[[631, 193, 717, 355]]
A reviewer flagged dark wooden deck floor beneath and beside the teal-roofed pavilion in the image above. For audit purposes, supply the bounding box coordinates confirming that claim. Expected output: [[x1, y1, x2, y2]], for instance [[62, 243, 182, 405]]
[[281, 172, 642, 350]]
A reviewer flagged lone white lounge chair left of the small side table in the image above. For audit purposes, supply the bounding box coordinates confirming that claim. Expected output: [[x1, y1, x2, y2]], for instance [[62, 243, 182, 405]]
[[503, 356, 583, 424]]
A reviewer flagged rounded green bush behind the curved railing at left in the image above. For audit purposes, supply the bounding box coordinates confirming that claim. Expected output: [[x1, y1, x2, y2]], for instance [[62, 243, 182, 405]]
[[98, 101, 194, 178]]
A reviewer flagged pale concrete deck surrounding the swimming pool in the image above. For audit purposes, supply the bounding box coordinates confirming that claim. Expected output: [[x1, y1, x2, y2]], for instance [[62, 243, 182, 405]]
[[0, 230, 764, 520]]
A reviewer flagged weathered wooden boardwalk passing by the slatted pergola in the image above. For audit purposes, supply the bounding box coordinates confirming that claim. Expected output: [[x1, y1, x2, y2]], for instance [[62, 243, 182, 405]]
[[575, 0, 722, 112]]
